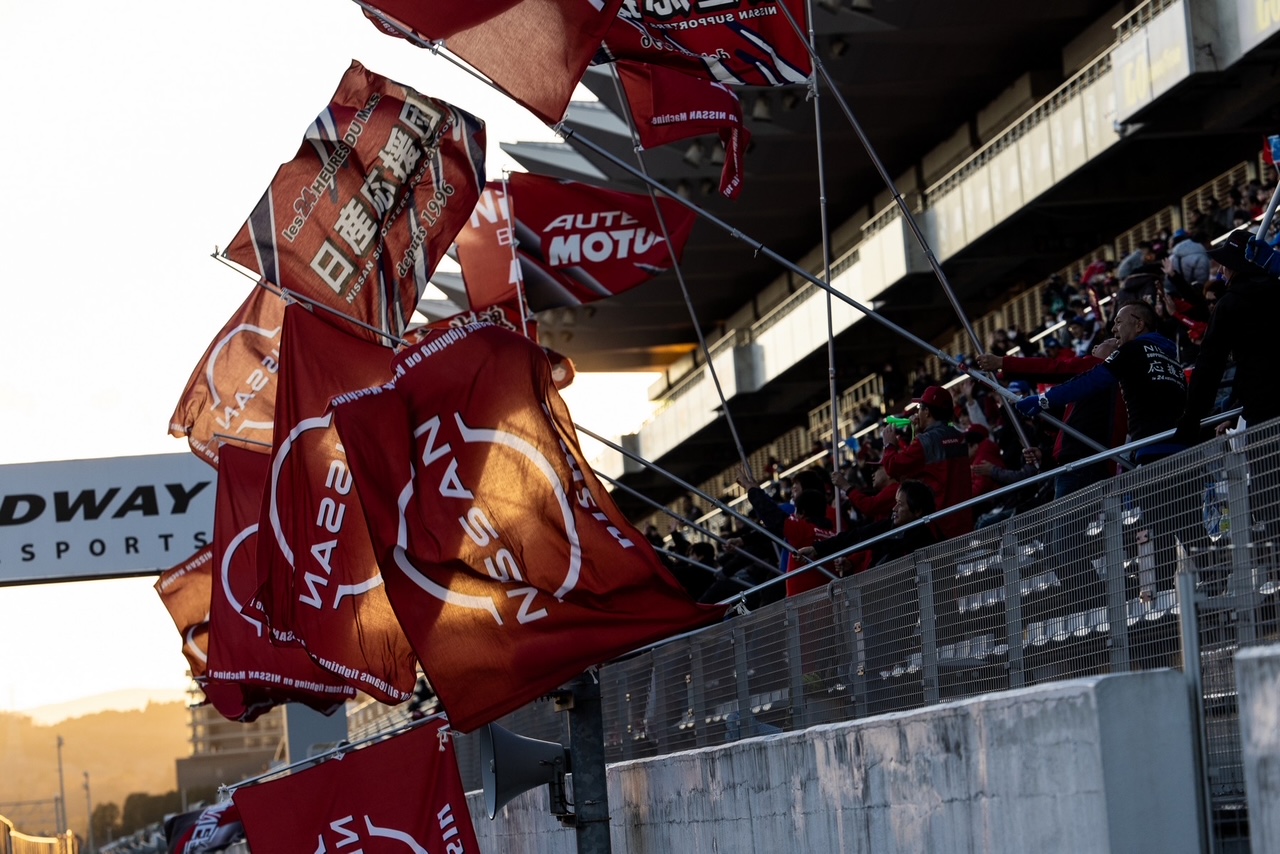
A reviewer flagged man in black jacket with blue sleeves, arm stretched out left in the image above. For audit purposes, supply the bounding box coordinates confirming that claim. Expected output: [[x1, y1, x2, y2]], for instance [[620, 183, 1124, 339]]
[[1016, 301, 1187, 465]]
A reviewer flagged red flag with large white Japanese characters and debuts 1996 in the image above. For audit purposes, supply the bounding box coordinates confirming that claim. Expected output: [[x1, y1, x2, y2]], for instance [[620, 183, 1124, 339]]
[[225, 61, 484, 341]]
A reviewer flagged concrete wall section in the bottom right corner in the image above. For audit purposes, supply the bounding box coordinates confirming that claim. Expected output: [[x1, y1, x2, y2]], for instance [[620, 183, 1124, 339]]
[[1235, 645, 1280, 854]]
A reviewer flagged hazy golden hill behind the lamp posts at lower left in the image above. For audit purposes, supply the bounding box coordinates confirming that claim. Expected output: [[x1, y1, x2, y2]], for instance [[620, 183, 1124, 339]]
[[0, 703, 191, 834]]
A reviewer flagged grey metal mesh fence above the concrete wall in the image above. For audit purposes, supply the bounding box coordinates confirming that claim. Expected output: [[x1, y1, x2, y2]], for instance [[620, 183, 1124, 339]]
[[458, 424, 1280, 842]]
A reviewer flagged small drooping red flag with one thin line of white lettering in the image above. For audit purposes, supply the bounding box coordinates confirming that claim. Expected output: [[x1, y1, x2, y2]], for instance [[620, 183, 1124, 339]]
[[617, 61, 751, 198]]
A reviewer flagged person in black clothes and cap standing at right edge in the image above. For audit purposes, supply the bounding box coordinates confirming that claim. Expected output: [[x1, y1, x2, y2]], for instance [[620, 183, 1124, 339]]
[[1176, 229, 1280, 444]]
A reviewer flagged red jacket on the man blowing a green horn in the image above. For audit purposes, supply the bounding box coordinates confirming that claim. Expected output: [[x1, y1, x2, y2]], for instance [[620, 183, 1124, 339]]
[[881, 424, 973, 539]]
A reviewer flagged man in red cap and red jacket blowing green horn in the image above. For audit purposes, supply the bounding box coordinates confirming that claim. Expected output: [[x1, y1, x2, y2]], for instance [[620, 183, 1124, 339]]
[[881, 385, 973, 539]]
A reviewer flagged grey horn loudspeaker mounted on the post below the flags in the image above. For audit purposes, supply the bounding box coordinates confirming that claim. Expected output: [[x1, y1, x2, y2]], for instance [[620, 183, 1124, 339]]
[[480, 723, 568, 819]]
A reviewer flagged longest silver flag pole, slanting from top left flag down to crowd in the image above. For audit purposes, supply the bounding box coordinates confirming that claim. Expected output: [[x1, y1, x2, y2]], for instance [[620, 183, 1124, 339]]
[[373, 23, 1130, 466]]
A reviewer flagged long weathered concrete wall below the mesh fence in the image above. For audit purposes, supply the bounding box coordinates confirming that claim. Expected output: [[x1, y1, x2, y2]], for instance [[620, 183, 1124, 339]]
[[471, 671, 1199, 854]]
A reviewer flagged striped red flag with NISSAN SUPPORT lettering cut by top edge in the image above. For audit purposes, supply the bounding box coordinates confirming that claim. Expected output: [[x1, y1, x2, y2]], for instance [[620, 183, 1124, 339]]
[[598, 0, 813, 86]]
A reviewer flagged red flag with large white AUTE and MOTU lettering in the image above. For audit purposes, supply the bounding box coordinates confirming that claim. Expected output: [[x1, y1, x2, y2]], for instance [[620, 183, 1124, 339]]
[[457, 173, 695, 311]]
